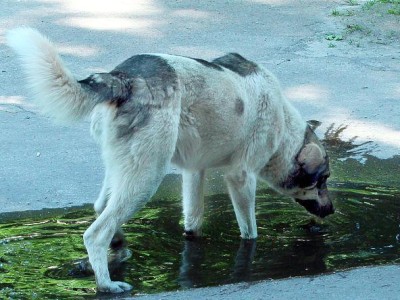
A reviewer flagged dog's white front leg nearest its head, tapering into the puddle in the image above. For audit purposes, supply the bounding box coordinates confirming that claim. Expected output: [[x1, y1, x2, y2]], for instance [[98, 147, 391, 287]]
[[226, 170, 257, 239]]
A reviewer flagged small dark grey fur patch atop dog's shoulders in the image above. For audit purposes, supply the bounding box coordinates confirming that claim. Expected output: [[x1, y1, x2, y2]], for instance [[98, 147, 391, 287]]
[[212, 53, 259, 77]]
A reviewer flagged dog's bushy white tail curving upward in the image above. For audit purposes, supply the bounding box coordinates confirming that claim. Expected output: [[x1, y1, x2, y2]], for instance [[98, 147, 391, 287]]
[[7, 28, 100, 122]]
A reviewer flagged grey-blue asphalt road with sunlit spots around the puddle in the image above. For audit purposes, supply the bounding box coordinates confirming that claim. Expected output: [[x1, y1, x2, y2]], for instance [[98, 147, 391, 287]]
[[0, 0, 400, 299]]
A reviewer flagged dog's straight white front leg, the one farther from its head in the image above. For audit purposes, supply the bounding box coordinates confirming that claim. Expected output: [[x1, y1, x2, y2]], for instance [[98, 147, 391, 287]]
[[182, 170, 205, 238]]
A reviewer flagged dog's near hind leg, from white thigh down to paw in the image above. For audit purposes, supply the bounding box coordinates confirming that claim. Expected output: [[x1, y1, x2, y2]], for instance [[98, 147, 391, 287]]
[[84, 107, 179, 293]]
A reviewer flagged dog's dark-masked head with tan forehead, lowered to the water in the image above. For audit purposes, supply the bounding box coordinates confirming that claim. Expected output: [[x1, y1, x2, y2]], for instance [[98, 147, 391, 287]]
[[279, 124, 335, 218]]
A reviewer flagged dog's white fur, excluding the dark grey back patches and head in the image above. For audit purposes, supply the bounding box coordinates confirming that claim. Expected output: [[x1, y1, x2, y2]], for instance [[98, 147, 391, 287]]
[[7, 28, 322, 292]]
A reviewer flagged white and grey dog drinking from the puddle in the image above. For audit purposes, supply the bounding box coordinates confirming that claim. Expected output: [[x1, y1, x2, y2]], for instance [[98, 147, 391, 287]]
[[7, 28, 334, 293]]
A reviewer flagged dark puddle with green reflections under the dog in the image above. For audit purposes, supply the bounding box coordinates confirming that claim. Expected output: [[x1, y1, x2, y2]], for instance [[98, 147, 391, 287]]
[[0, 127, 400, 299]]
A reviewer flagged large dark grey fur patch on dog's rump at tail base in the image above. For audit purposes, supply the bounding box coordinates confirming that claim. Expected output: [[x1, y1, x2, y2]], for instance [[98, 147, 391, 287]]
[[79, 54, 178, 138]]
